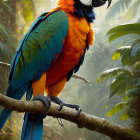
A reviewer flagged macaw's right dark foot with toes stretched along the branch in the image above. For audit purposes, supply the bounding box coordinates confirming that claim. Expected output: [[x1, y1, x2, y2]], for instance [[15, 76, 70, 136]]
[[50, 96, 82, 115]]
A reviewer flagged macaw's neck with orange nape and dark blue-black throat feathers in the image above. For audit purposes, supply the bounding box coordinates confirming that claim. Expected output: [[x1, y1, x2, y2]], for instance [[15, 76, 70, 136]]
[[58, 0, 95, 22]]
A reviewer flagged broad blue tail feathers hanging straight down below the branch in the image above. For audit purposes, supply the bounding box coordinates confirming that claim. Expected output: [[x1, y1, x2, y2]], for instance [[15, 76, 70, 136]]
[[21, 113, 44, 140]]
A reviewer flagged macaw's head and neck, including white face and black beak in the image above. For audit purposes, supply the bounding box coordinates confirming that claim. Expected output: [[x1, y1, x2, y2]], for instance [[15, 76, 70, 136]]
[[58, 0, 112, 22]]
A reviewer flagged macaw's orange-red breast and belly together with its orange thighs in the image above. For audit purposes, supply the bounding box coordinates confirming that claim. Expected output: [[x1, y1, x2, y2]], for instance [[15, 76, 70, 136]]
[[32, 13, 94, 96]]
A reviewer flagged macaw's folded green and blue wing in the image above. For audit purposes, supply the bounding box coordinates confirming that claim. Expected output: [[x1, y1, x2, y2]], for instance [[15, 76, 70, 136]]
[[9, 11, 69, 94]]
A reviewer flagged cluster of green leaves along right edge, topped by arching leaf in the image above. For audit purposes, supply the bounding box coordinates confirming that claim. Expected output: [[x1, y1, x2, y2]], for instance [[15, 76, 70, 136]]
[[97, 23, 140, 116]]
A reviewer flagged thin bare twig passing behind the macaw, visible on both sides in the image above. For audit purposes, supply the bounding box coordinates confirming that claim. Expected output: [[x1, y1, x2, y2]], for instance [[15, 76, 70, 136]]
[[0, 62, 90, 84]]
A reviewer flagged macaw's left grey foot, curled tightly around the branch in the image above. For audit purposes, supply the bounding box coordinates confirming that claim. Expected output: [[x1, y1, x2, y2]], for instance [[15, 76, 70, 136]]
[[32, 94, 51, 111]]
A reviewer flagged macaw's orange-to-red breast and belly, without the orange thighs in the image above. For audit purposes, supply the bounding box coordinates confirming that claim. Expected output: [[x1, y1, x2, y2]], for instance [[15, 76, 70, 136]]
[[46, 14, 94, 85]]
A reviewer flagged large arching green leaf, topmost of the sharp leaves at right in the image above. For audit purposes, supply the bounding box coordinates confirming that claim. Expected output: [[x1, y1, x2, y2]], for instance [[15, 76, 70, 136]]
[[107, 23, 140, 42]]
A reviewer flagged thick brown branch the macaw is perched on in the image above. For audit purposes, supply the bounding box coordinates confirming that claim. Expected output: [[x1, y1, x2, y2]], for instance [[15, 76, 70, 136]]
[[0, 94, 140, 140]]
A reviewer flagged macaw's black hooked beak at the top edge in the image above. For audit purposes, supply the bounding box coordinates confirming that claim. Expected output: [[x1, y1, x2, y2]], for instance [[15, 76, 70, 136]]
[[92, 0, 112, 8]]
